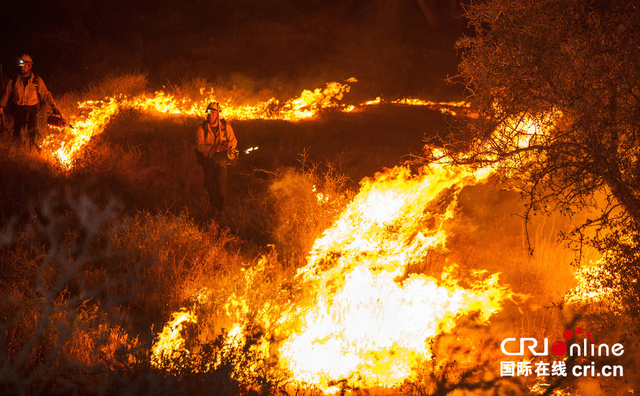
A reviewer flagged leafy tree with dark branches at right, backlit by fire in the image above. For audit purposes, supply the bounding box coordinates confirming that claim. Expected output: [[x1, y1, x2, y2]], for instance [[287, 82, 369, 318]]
[[445, 0, 640, 311]]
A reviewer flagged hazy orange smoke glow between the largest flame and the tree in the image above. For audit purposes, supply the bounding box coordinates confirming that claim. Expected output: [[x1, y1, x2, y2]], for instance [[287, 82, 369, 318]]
[[448, 182, 584, 307]]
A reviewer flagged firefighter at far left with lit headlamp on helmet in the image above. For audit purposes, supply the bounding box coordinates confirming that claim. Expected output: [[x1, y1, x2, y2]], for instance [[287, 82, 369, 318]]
[[0, 54, 60, 149]]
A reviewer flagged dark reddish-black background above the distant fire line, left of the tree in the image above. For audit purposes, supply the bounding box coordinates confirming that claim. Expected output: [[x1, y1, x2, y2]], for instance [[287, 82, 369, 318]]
[[0, 0, 465, 96]]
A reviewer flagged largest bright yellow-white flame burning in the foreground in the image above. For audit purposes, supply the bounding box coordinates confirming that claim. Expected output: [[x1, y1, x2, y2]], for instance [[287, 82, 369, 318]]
[[280, 165, 511, 393]]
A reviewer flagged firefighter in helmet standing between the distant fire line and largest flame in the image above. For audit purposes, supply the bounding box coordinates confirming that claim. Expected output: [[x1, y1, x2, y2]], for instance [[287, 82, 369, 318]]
[[196, 102, 238, 220]]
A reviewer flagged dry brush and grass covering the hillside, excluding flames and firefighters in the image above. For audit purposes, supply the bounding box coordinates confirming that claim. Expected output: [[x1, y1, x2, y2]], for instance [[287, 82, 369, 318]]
[[0, 74, 632, 395]]
